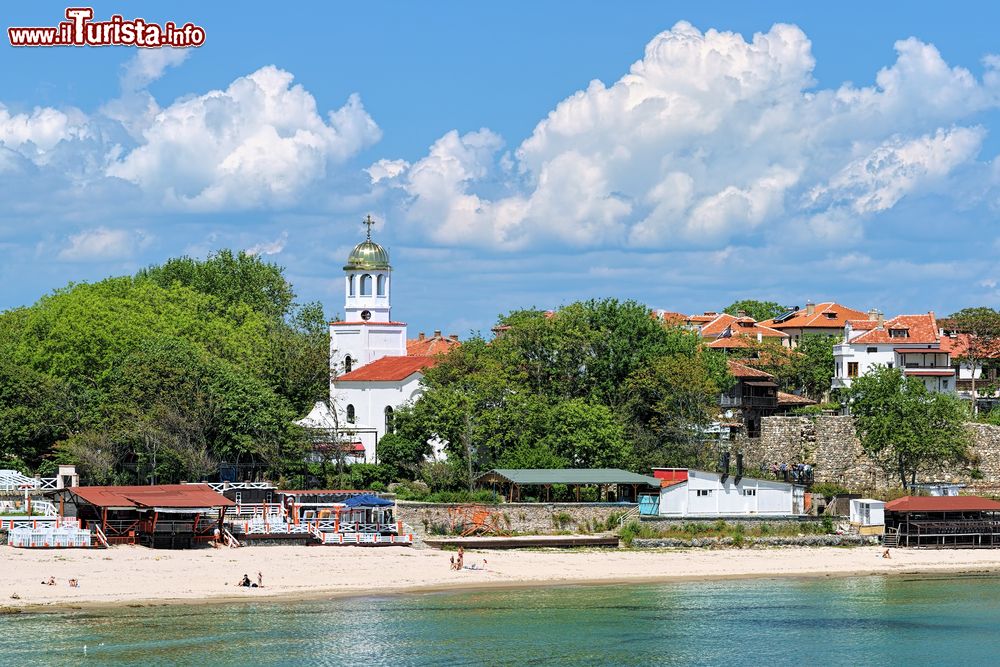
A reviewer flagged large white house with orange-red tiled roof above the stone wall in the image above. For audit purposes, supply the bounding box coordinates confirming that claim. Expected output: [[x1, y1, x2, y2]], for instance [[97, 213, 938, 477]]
[[832, 313, 955, 393]]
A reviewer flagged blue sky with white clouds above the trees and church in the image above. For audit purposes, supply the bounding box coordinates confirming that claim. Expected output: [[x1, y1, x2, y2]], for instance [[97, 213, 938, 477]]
[[0, 1, 1000, 337]]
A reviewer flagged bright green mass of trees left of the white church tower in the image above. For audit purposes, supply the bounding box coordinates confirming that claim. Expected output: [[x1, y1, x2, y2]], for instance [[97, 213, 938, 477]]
[[0, 251, 329, 483]]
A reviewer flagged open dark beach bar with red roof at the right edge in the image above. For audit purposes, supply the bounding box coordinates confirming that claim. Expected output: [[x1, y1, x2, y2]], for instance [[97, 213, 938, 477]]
[[885, 496, 1000, 549]]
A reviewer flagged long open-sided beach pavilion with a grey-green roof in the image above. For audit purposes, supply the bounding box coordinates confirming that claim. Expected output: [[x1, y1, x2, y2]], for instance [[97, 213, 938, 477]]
[[475, 468, 660, 503]]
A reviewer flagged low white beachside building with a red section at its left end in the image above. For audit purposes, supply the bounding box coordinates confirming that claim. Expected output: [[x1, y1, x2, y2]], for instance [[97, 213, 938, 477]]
[[643, 468, 809, 518]]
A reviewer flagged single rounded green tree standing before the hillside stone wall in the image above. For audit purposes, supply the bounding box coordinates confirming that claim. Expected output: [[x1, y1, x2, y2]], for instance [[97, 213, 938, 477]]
[[847, 366, 968, 486]]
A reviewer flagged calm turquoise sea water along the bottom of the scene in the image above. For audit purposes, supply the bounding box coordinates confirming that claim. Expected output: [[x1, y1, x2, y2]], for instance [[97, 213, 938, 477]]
[[0, 576, 1000, 667]]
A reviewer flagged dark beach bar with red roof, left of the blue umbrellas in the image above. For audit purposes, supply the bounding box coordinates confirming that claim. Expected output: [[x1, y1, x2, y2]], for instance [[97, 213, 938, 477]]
[[52, 484, 235, 549]]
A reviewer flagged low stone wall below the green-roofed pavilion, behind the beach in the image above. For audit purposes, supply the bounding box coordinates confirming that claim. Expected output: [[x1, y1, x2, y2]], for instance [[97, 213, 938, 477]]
[[396, 500, 635, 540]]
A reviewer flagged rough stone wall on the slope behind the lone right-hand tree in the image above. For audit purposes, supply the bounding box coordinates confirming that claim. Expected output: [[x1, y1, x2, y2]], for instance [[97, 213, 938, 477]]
[[737, 415, 1000, 493]]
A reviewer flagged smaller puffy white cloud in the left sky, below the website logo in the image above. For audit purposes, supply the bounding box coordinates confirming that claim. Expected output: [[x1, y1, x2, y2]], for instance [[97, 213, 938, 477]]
[[107, 66, 381, 210]]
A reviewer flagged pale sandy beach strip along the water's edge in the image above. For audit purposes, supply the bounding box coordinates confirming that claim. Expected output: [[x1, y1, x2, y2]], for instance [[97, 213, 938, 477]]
[[0, 546, 1000, 608]]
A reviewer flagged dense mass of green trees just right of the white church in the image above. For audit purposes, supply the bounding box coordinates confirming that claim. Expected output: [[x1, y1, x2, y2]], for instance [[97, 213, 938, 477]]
[[383, 299, 732, 488]]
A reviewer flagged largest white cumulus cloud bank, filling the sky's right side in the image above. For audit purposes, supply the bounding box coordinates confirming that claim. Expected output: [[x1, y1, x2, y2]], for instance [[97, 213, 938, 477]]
[[388, 22, 1000, 249]]
